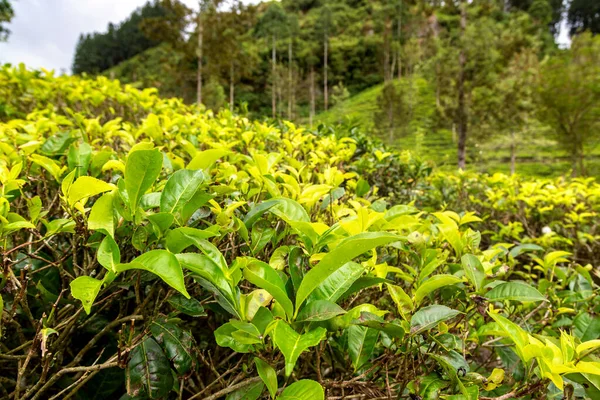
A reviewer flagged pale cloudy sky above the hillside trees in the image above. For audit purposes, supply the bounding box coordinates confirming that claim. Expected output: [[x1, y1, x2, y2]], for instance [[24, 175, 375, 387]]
[[0, 0, 569, 72]]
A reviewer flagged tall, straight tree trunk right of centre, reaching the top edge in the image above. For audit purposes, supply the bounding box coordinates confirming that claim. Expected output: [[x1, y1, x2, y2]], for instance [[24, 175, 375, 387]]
[[457, 0, 468, 169]]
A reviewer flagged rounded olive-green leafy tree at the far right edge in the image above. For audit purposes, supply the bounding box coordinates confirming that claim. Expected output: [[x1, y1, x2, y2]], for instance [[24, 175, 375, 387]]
[[539, 33, 600, 175]]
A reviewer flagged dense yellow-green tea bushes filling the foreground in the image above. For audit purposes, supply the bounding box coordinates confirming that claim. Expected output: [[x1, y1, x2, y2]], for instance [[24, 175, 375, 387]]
[[0, 67, 600, 400]]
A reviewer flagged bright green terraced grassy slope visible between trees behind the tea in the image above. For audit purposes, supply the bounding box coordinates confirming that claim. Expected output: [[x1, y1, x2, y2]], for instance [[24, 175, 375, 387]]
[[316, 85, 600, 176]]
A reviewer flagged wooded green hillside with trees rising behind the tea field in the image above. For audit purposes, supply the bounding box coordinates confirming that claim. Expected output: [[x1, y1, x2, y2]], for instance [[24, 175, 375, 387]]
[[68, 0, 600, 175]]
